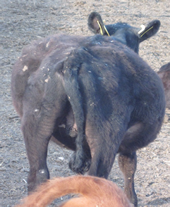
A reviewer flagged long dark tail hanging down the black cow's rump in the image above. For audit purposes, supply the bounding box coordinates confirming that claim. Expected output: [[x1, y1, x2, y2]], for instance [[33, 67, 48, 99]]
[[63, 49, 90, 173]]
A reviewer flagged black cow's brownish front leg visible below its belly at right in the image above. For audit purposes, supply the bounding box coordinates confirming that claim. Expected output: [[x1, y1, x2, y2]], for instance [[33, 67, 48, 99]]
[[118, 152, 137, 207]]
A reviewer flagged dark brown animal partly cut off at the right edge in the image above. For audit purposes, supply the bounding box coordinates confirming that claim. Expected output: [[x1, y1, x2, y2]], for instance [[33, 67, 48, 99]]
[[158, 63, 170, 109]]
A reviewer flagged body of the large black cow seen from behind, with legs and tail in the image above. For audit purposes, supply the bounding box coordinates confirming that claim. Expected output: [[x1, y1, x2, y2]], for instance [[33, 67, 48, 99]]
[[11, 11, 165, 206]]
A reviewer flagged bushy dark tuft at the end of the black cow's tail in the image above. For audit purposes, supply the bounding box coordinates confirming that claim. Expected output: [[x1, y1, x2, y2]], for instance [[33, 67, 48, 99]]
[[69, 152, 91, 174]]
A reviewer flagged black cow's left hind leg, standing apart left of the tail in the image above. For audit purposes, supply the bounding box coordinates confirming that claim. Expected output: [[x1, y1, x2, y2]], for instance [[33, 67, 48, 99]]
[[22, 111, 53, 192]]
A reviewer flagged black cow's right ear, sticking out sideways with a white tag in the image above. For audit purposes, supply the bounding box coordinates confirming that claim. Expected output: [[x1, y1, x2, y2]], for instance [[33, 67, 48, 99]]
[[138, 20, 161, 42]]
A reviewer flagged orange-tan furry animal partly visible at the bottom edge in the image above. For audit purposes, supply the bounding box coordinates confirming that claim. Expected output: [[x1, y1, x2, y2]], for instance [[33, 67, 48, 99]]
[[16, 176, 131, 207]]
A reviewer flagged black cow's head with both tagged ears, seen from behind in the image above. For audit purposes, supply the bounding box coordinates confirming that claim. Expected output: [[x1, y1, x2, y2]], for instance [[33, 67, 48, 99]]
[[88, 12, 160, 53]]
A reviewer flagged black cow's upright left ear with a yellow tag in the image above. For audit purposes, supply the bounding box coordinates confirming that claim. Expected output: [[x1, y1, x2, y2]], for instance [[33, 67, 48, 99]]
[[88, 12, 105, 35]]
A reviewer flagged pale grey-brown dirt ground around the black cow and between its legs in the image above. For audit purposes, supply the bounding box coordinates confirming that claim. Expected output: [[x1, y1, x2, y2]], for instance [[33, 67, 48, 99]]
[[0, 0, 170, 207]]
